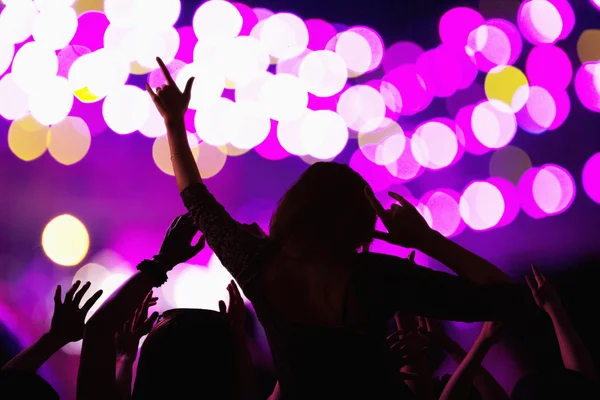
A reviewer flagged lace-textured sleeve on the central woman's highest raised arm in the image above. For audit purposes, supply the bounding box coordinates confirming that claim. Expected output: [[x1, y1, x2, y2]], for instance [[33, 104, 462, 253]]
[[181, 183, 269, 288]]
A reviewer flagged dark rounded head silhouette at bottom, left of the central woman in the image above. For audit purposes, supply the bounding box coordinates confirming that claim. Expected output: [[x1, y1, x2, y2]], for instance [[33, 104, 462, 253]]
[[133, 309, 239, 400]]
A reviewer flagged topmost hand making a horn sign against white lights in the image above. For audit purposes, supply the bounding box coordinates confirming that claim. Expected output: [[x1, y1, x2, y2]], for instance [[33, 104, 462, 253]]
[[146, 57, 194, 120]]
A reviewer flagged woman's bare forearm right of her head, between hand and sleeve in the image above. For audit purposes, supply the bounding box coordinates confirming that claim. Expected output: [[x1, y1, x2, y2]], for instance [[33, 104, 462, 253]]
[[418, 231, 513, 285]]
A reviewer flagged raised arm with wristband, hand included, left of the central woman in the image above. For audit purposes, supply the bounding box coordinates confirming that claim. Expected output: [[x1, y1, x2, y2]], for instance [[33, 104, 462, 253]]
[[77, 214, 204, 400]]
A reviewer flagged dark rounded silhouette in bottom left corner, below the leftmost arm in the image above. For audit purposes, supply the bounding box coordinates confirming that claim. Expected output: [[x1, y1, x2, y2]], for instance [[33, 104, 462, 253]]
[[0, 371, 60, 400]]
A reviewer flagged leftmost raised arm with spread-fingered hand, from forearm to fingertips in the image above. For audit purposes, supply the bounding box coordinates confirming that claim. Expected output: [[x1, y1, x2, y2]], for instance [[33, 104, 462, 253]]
[[2, 281, 102, 373]]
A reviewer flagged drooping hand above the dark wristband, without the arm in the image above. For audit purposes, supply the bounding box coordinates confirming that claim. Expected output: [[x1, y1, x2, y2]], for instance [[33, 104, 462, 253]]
[[154, 214, 205, 271]]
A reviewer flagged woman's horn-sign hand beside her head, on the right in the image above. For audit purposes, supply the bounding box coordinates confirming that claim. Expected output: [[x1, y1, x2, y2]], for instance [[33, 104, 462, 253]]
[[365, 187, 433, 248]]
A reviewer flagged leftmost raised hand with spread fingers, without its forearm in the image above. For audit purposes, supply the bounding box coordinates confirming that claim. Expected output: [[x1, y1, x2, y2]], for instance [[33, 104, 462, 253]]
[[48, 281, 102, 344]]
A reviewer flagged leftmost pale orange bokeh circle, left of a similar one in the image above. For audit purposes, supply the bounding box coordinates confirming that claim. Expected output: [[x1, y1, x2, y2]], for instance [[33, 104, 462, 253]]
[[8, 115, 48, 161]]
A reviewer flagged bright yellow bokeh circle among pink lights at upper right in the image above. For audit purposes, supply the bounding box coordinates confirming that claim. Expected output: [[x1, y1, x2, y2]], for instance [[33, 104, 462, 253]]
[[485, 66, 529, 112]]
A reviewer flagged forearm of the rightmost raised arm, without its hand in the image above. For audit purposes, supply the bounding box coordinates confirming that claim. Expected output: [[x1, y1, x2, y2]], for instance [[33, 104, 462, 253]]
[[548, 305, 597, 380]]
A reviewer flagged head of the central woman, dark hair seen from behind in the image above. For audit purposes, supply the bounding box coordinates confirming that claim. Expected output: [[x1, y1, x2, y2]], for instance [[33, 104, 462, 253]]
[[270, 162, 376, 254]]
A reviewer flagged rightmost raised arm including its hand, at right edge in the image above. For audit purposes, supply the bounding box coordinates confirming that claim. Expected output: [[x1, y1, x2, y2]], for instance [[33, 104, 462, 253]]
[[527, 265, 598, 380]]
